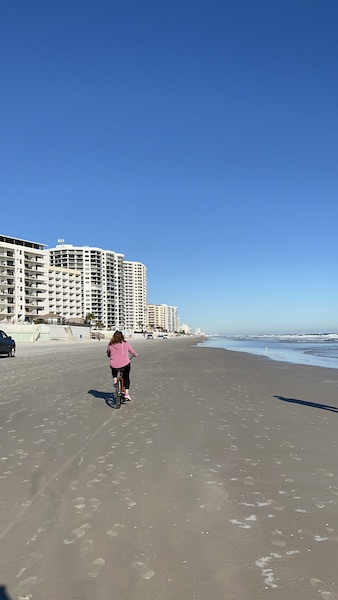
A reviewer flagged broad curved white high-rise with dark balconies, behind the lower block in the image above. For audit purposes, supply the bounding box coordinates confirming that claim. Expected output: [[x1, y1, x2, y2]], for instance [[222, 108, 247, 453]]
[[48, 240, 125, 329]]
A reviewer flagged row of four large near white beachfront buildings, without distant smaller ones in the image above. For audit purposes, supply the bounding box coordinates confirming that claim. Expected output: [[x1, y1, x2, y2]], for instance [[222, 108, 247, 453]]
[[0, 235, 147, 329]]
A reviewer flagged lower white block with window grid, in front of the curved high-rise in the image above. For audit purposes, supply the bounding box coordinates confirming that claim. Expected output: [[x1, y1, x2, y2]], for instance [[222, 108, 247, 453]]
[[45, 265, 83, 322]]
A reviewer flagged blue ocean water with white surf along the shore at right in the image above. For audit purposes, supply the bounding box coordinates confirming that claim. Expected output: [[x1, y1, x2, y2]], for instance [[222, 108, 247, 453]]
[[199, 333, 338, 369]]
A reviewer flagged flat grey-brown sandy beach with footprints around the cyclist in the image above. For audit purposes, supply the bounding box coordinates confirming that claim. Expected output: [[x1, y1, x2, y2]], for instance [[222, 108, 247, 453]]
[[0, 338, 338, 600]]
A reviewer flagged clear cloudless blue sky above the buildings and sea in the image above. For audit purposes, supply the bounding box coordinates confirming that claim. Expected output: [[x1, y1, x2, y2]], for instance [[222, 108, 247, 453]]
[[0, 0, 338, 334]]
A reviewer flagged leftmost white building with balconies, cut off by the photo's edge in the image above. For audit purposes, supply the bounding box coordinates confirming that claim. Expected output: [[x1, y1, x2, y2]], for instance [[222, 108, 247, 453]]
[[0, 235, 47, 323]]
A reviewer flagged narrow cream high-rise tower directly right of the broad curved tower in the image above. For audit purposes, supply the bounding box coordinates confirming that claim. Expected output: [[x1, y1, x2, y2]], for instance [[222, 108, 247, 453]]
[[123, 260, 147, 330]]
